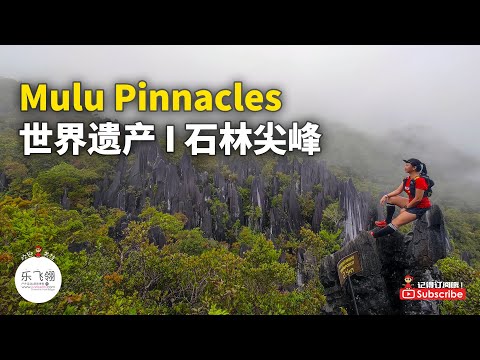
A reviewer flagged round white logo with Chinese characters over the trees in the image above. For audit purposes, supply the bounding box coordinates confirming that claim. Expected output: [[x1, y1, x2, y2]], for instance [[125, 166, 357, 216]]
[[15, 256, 62, 304]]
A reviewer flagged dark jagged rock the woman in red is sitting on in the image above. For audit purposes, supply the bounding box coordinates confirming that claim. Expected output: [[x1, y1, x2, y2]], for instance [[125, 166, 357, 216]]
[[320, 205, 451, 315]]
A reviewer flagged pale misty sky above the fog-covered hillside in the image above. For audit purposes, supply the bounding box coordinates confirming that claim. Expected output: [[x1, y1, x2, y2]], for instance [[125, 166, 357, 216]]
[[0, 46, 480, 156]]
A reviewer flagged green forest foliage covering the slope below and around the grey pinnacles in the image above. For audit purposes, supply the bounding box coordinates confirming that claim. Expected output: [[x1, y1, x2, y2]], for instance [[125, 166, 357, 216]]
[[0, 90, 480, 314]]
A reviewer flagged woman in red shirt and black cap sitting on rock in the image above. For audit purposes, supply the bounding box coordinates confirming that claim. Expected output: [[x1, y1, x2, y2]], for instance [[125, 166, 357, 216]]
[[370, 158, 434, 238]]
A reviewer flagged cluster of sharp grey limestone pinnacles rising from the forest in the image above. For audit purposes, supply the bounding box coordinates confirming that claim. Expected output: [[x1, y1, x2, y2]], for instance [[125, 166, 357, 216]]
[[94, 142, 375, 243]]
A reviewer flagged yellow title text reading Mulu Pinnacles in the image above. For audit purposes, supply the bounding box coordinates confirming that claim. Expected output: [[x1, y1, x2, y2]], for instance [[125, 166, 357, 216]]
[[20, 80, 282, 112]]
